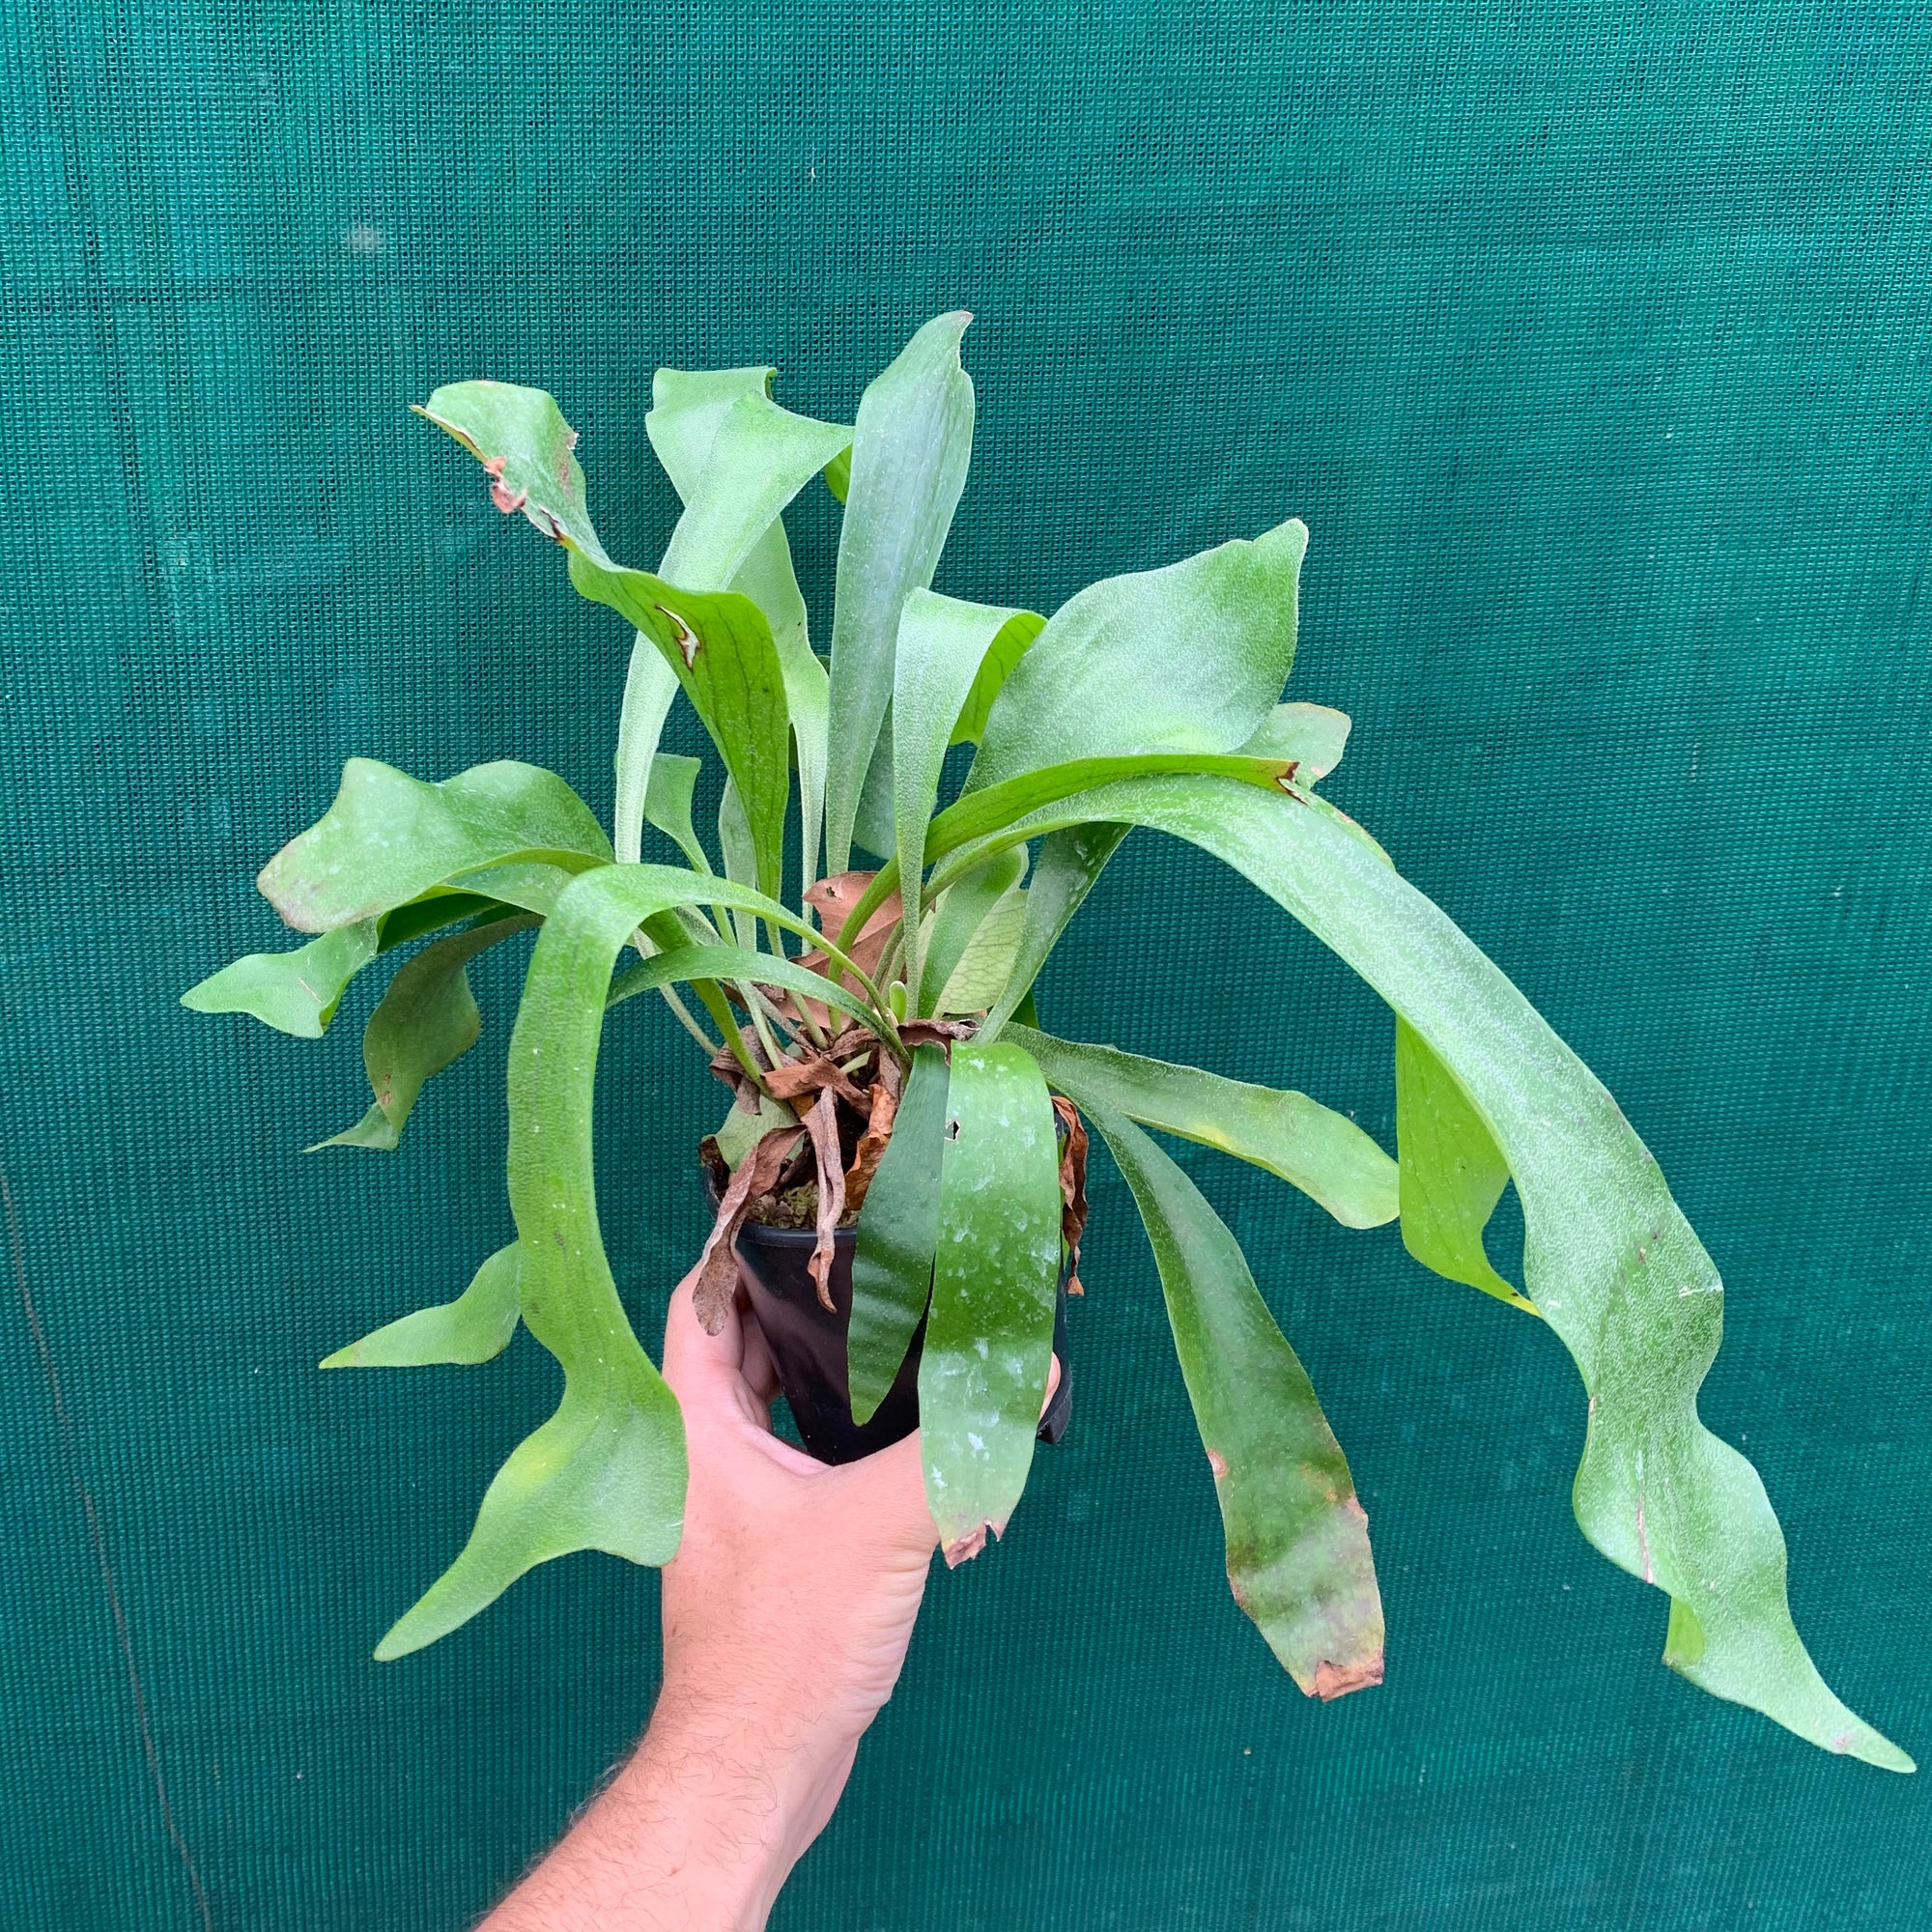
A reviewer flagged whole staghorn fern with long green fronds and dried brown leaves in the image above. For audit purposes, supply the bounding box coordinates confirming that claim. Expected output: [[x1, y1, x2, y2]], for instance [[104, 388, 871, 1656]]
[[185, 313, 1911, 1770]]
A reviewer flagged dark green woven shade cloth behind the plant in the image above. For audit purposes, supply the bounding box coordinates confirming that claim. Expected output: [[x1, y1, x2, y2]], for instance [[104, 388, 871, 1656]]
[[0, 0, 1932, 1932]]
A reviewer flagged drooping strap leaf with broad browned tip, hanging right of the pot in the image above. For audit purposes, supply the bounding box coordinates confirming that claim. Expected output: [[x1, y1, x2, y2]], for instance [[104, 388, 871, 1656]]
[[1080, 1101, 1383, 1698]]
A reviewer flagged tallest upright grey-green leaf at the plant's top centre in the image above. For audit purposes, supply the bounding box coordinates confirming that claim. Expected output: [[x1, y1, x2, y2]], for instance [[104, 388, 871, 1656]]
[[825, 309, 974, 871]]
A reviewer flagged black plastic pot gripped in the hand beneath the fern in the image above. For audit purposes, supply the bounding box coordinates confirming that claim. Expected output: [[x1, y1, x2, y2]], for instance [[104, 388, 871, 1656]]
[[738, 1221, 1074, 1463]]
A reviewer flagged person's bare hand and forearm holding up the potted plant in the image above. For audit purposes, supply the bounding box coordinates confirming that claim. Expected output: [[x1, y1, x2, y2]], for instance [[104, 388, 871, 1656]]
[[485, 1269, 1059, 1932]]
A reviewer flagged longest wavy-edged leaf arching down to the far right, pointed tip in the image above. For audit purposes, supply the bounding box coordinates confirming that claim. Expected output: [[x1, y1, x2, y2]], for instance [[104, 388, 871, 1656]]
[[989, 777, 1911, 1770]]
